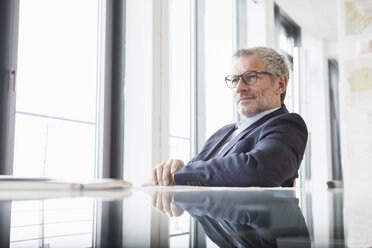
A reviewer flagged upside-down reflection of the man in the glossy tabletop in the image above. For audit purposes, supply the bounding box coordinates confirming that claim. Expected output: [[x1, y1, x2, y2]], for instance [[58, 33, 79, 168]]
[[152, 190, 311, 247]]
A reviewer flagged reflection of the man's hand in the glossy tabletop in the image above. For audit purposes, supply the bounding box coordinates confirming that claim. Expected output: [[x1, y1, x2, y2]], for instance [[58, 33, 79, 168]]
[[151, 191, 184, 217]]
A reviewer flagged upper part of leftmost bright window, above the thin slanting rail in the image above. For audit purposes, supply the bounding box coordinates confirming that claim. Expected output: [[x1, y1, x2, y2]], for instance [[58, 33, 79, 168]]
[[17, 0, 98, 122]]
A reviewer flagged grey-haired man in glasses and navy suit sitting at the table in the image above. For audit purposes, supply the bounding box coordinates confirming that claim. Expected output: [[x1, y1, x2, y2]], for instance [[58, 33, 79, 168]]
[[148, 47, 307, 187]]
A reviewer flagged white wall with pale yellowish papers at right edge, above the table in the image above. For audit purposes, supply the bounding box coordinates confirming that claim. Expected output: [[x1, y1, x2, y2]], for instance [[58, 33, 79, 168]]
[[338, 1, 372, 188]]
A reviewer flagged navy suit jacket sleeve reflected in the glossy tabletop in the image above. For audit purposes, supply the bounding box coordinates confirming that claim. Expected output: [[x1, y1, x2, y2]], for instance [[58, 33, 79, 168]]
[[174, 191, 309, 239]]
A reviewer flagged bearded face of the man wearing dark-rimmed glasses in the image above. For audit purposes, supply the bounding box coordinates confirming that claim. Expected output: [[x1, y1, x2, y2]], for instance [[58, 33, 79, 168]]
[[232, 55, 287, 117]]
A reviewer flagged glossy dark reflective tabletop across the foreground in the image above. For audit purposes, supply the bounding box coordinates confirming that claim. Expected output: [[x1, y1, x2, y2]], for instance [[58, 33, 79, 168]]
[[0, 186, 372, 247]]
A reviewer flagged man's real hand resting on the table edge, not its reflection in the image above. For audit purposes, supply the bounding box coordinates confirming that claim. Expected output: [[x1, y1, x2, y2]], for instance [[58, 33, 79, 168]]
[[143, 159, 184, 186]]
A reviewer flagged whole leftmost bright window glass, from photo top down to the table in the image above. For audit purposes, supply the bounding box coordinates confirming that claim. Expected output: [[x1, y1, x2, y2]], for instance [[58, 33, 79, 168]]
[[14, 0, 99, 179]]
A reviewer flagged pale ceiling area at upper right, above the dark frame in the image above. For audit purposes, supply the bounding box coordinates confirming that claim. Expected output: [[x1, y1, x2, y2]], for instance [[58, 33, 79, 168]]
[[275, 0, 337, 40]]
